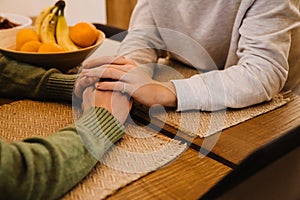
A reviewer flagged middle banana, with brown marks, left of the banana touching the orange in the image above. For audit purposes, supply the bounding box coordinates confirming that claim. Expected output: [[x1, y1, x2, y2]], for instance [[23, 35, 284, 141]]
[[40, 6, 59, 43]]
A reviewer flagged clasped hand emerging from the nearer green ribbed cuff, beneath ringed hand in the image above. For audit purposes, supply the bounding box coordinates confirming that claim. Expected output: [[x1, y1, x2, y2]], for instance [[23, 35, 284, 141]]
[[82, 86, 132, 123]]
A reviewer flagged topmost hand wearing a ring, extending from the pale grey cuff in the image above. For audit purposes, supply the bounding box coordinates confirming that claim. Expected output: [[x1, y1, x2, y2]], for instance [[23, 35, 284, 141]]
[[82, 61, 177, 107]]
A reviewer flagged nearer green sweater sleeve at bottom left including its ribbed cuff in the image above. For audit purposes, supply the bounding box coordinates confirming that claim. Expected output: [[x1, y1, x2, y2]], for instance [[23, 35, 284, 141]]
[[0, 108, 124, 199]]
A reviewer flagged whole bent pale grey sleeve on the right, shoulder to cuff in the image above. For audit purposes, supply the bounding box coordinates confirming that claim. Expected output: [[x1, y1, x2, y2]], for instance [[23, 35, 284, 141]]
[[173, 1, 299, 111]]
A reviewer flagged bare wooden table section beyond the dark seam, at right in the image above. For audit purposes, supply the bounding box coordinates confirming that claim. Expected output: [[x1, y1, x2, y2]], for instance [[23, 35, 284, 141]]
[[135, 97, 300, 168]]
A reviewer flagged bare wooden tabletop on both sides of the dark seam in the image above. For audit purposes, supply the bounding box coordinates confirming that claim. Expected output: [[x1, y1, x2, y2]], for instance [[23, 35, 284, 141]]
[[103, 93, 300, 199]]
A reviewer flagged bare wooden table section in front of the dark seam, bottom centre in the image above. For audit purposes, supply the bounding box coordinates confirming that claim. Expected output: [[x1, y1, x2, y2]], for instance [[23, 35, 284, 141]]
[[108, 149, 231, 200]]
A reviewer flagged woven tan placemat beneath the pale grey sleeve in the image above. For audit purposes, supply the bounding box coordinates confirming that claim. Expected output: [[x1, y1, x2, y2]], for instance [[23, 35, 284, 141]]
[[143, 59, 292, 138]]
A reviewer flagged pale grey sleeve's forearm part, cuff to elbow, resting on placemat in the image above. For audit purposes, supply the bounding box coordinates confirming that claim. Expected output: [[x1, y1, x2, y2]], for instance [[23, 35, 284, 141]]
[[172, 66, 284, 111]]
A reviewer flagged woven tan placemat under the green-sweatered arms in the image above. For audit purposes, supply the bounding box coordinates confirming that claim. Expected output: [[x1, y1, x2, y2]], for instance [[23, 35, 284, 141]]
[[0, 100, 187, 200]]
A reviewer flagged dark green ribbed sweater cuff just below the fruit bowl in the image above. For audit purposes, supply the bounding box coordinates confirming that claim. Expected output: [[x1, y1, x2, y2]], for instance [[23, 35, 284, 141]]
[[44, 73, 77, 102]]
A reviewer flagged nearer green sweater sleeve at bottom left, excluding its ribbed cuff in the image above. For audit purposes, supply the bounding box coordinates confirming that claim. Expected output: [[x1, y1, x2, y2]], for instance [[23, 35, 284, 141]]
[[0, 130, 97, 199]]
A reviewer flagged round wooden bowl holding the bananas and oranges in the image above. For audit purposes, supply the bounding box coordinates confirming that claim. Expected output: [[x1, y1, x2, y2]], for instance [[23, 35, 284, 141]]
[[0, 29, 105, 73]]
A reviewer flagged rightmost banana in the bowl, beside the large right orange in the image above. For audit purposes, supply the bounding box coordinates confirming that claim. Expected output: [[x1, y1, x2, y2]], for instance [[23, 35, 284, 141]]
[[56, 9, 78, 51]]
